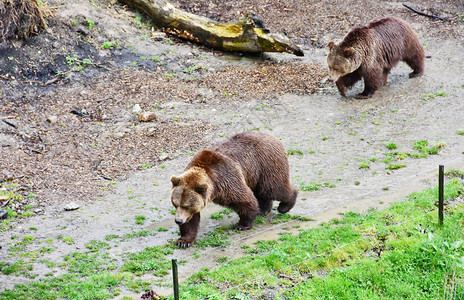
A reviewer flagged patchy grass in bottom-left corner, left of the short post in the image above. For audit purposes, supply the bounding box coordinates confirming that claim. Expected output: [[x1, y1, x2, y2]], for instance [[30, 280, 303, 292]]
[[0, 241, 173, 300]]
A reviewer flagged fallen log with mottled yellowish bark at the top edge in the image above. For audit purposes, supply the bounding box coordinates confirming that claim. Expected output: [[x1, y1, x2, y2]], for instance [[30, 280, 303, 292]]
[[119, 0, 304, 56]]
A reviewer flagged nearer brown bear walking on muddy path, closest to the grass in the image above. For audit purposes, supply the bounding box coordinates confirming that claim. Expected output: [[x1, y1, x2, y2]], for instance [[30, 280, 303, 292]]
[[171, 131, 298, 248]]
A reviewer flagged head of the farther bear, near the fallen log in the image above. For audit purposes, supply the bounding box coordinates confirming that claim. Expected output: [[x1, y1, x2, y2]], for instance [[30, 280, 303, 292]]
[[327, 42, 362, 81]]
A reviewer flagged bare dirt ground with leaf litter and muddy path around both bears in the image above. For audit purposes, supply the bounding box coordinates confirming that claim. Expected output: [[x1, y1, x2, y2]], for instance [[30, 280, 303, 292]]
[[0, 0, 464, 291]]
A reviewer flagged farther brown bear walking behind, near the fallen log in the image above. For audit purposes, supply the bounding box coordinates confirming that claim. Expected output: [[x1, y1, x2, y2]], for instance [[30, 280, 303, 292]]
[[327, 17, 424, 99]]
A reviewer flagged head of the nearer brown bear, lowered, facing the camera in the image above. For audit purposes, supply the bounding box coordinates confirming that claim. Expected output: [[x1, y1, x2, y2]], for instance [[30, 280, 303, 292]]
[[171, 167, 213, 225]]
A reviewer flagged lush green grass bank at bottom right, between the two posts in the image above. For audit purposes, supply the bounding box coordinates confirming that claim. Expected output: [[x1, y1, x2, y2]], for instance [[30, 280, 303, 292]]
[[180, 179, 464, 299]]
